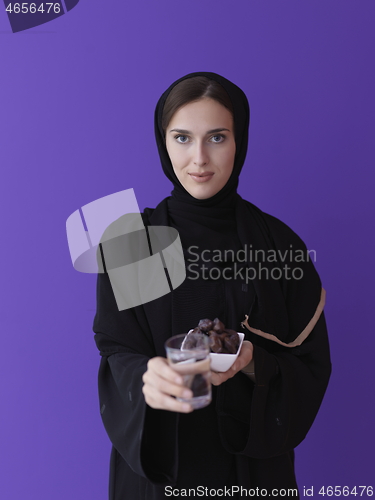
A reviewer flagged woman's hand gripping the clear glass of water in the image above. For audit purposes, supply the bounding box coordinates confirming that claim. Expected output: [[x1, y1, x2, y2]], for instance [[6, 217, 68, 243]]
[[142, 356, 193, 413]]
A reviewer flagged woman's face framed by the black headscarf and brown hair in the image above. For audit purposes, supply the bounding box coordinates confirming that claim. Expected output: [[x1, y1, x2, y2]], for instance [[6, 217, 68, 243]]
[[166, 98, 236, 200]]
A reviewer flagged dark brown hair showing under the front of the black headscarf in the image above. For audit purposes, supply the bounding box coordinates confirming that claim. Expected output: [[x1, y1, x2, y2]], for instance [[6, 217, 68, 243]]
[[162, 76, 234, 137]]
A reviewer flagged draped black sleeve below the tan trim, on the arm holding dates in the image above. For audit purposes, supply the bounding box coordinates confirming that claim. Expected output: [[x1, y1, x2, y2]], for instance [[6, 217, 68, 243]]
[[218, 314, 331, 458]]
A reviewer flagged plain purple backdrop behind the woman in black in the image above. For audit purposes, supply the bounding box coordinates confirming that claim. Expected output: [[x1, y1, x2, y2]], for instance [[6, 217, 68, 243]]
[[0, 0, 375, 500]]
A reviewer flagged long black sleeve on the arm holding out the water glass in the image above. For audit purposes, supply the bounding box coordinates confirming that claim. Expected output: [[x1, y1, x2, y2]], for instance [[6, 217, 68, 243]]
[[93, 274, 177, 484]]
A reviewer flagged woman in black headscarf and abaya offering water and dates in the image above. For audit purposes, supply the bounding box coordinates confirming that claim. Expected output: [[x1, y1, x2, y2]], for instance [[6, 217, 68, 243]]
[[93, 73, 331, 500]]
